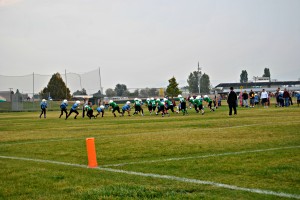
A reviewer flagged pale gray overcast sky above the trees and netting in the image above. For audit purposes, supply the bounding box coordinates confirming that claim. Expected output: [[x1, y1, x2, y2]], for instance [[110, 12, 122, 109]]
[[0, 0, 300, 94]]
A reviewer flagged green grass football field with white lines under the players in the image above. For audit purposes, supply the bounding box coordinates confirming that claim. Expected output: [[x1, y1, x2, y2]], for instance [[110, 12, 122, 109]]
[[0, 105, 300, 199]]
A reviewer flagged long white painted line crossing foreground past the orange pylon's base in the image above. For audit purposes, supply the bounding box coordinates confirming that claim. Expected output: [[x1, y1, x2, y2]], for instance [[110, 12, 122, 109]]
[[0, 156, 300, 199]]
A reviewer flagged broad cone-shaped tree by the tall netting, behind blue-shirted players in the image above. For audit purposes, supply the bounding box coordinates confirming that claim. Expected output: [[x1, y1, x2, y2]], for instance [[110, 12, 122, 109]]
[[40, 72, 71, 100]]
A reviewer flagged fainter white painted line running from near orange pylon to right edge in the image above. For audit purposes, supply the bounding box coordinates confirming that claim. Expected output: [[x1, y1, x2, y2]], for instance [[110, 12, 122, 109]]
[[102, 146, 300, 167]]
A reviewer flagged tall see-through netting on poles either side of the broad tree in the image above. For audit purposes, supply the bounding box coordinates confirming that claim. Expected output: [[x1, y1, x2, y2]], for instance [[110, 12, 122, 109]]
[[0, 70, 103, 111]]
